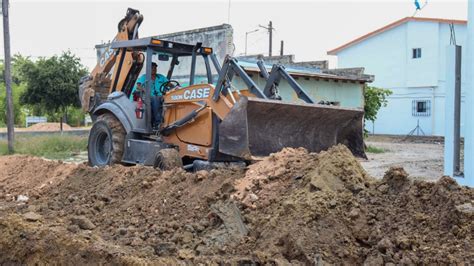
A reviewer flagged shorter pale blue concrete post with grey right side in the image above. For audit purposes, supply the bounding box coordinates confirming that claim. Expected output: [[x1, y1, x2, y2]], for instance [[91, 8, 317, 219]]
[[444, 45, 461, 177]]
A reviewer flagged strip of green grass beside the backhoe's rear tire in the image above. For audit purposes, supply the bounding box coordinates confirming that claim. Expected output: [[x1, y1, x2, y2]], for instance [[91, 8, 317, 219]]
[[0, 134, 87, 160]]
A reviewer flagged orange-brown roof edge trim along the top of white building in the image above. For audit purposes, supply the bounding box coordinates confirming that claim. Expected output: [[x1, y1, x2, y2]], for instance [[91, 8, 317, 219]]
[[327, 17, 467, 55]]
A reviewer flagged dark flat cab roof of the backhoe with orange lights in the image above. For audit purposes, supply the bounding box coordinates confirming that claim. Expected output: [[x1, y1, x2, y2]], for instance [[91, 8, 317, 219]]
[[111, 37, 212, 56]]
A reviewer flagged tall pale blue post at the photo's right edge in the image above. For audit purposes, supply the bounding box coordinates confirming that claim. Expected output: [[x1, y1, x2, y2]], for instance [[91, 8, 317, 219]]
[[457, 0, 474, 187]]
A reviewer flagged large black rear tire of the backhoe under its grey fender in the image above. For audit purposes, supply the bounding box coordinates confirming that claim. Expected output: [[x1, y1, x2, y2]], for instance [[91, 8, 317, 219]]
[[87, 113, 126, 166]]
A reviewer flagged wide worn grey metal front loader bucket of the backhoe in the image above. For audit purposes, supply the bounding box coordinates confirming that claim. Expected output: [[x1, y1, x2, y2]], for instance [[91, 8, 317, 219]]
[[219, 97, 367, 160]]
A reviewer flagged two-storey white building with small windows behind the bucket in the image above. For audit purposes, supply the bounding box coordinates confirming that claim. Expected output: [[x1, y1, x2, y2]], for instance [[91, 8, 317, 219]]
[[328, 17, 467, 136]]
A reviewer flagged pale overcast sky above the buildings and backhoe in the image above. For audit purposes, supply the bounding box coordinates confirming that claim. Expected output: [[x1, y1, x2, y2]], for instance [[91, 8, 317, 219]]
[[0, 0, 467, 68]]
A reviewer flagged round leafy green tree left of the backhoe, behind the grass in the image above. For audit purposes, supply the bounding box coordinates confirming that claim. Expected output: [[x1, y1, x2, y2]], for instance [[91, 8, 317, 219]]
[[20, 52, 87, 128]]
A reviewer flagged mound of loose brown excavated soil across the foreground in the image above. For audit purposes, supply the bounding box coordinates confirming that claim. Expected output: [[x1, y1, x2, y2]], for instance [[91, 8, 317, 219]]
[[0, 146, 474, 265]]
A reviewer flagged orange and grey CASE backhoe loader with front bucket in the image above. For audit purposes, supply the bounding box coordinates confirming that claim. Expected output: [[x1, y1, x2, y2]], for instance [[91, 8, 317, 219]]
[[79, 9, 365, 169]]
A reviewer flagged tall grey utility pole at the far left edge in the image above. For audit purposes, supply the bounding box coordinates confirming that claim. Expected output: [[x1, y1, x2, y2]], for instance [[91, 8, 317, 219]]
[[2, 0, 14, 153]]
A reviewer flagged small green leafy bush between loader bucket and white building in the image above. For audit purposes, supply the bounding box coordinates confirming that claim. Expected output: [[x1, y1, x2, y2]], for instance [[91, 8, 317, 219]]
[[364, 86, 392, 134]]
